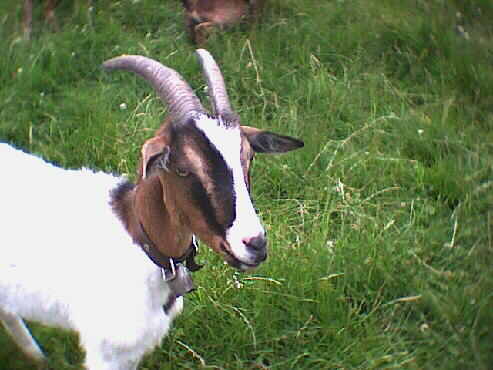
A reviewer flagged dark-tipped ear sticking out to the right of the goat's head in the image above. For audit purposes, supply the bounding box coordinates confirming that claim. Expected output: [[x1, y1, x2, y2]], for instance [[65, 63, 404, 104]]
[[241, 126, 305, 154]]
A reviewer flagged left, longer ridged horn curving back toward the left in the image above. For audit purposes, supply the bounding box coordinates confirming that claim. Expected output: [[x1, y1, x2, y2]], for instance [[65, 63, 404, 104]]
[[103, 55, 205, 122]]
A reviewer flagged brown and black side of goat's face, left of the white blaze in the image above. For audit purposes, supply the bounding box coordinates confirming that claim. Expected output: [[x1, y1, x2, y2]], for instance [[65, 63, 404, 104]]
[[148, 123, 235, 251]]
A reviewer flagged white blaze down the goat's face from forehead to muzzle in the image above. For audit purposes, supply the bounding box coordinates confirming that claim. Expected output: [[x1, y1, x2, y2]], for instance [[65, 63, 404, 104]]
[[195, 115, 265, 265]]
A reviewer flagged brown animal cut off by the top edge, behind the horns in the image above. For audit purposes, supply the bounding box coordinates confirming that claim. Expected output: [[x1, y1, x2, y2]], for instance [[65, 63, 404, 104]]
[[182, 0, 264, 45]]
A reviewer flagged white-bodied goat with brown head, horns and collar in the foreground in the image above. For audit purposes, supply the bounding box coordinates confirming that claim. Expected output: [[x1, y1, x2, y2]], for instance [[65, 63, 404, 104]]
[[0, 50, 303, 370]]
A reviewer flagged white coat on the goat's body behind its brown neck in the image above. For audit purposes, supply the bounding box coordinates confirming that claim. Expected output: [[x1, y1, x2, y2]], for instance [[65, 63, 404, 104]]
[[0, 143, 183, 370]]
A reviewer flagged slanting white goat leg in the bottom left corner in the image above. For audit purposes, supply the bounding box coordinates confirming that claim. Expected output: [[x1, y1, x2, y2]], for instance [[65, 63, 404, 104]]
[[0, 309, 45, 362]]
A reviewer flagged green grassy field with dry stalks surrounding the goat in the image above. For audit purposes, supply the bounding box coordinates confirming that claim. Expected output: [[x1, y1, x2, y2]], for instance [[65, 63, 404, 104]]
[[0, 0, 493, 370]]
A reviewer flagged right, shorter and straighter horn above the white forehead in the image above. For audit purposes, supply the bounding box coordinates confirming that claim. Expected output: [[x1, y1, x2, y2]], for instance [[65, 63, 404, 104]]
[[195, 49, 236, 116]]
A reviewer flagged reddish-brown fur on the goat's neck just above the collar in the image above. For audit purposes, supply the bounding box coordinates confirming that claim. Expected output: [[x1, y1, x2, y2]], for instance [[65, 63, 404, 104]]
[[127, 176, 192, 258]]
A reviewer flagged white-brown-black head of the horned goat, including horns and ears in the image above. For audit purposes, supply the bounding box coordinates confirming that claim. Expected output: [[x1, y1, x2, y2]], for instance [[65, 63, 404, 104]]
[[103, 50, 303, 270]]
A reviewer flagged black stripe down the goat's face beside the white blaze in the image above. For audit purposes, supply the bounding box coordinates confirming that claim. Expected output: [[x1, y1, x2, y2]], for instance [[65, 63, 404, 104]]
[[176, 125, 236, 238]]
